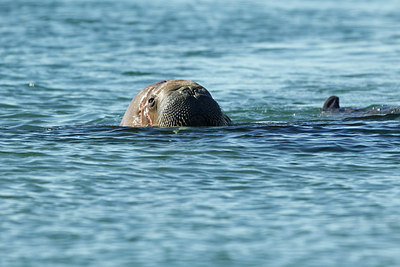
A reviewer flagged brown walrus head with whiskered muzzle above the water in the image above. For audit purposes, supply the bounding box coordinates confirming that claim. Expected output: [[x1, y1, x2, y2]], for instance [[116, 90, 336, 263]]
[[120, 80, 232, 127]]
